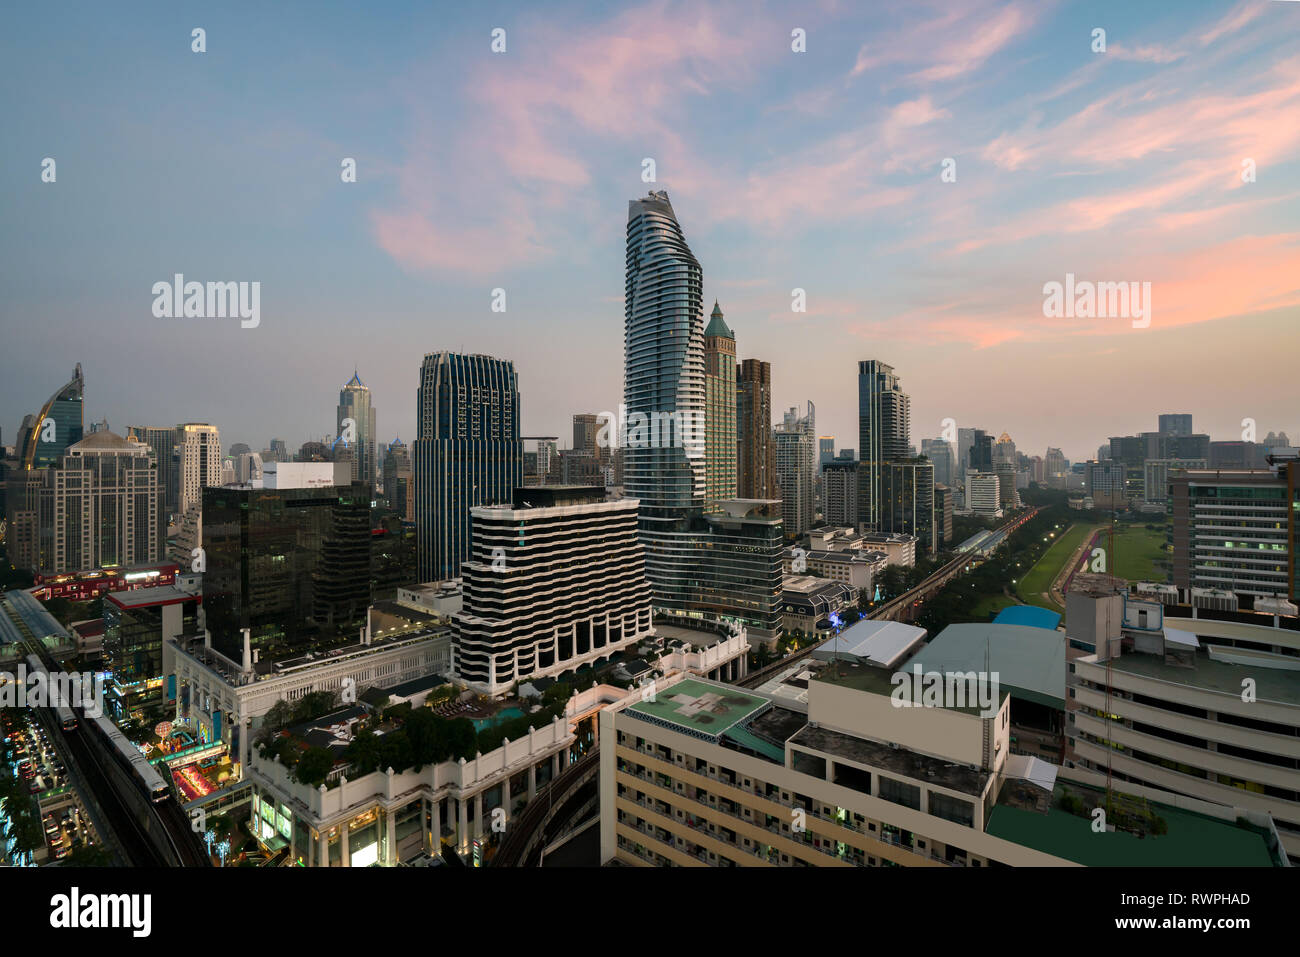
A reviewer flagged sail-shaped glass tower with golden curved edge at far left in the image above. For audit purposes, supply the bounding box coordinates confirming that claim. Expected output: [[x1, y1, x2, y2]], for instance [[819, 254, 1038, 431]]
[[5, 363, 86, 571]]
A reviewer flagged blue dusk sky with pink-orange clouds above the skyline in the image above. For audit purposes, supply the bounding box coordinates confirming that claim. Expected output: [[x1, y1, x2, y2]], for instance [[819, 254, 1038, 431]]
[[0, 0, 1300, 460]]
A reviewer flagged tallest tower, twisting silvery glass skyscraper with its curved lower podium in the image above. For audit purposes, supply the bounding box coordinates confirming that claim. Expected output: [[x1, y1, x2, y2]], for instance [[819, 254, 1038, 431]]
[[623, 192, 781, 641]]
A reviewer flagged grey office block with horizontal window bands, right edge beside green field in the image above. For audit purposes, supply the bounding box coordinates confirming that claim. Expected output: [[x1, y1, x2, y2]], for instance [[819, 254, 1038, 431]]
[[1169, 455, 1300, 601]]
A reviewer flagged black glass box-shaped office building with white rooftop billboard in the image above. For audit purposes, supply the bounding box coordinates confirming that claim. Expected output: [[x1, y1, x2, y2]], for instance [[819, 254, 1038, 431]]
[[203, 462, 371, 663]]
